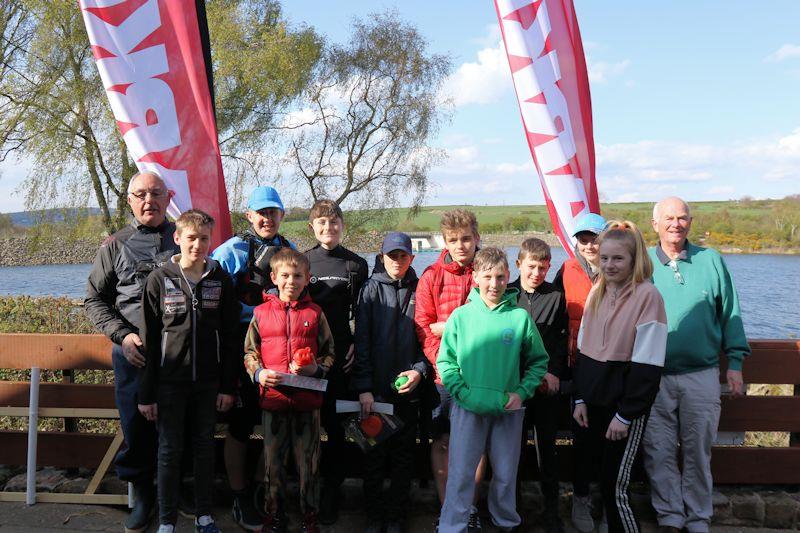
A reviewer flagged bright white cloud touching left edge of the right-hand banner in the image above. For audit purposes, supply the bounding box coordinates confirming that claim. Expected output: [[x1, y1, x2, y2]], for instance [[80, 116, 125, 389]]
[[442, 41, 513, 106]]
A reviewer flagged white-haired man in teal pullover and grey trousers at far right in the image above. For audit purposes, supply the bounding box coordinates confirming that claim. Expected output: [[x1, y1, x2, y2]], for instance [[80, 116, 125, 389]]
[[643, 197, 750, 533]]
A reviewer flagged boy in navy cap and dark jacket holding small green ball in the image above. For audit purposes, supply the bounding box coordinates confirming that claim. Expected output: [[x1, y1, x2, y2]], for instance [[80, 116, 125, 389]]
[[350, 232, 429, 533]]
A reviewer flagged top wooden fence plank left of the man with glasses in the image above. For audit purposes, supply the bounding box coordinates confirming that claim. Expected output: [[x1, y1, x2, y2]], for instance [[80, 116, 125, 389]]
[[0, 333, 111, 370]]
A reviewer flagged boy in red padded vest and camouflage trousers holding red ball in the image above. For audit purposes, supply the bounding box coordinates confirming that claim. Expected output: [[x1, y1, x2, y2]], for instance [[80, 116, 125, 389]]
[[244, 248, 334, 532]]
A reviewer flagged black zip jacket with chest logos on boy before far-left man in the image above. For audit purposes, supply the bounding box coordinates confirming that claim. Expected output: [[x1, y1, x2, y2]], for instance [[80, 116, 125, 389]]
[[139, 255, 242, 405]]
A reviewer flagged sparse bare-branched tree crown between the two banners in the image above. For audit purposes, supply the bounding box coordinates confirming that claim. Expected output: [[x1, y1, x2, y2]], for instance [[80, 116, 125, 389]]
[[289, 12, 451, 229]]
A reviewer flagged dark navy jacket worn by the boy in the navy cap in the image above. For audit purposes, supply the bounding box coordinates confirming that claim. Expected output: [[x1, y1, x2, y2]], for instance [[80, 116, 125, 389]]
[[350, 257, 430, 403]]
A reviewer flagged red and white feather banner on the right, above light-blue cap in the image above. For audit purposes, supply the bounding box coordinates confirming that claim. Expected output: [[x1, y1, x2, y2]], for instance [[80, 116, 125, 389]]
[[495, 0, 600, 254]]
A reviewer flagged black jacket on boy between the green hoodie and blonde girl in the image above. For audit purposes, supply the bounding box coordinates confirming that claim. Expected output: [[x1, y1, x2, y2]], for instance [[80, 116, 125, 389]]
[[508, 278, 569, 379]]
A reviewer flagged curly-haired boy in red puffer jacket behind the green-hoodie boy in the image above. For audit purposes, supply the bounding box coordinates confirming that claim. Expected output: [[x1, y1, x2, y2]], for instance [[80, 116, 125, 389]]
[[414, 209, 482, 527]]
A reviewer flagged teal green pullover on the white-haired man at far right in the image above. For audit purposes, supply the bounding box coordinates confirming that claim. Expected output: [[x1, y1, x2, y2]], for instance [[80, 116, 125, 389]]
[[649, 242, 750, 374]]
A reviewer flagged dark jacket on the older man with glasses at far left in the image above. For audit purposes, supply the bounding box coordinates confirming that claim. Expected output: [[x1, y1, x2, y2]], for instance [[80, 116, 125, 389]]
[[83, 220, 180, 344]]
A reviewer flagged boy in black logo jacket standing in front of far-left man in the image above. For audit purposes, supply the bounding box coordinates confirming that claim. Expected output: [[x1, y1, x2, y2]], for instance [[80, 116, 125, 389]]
[[139, 209, 241, 533]]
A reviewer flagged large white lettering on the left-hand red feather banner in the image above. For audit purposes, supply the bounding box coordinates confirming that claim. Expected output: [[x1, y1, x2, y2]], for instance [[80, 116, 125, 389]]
[[80, 0, 192, 208]]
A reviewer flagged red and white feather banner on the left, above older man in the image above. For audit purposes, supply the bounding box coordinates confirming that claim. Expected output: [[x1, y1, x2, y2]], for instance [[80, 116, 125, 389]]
[[79, 0, 231, 247]]
